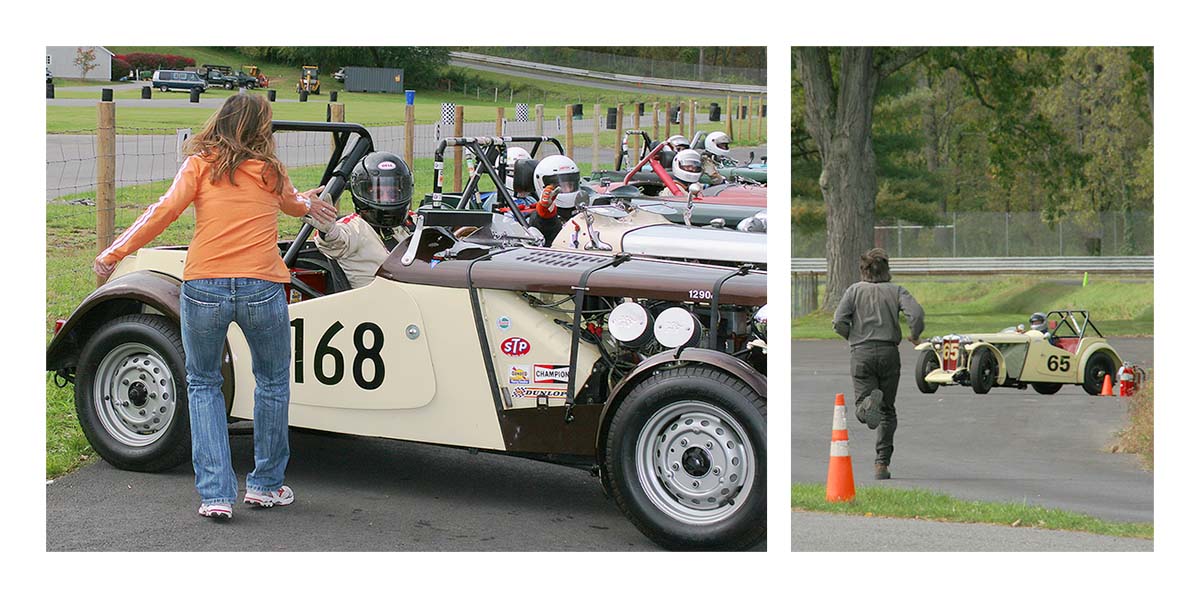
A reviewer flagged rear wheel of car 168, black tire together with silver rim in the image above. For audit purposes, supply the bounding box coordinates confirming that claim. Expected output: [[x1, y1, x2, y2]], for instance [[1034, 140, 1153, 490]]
[[74, 313, 192, 472]]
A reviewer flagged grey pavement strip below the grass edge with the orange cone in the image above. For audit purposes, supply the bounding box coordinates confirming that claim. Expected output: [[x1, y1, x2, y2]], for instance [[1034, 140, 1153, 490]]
[[792, 512, 1154, 552]]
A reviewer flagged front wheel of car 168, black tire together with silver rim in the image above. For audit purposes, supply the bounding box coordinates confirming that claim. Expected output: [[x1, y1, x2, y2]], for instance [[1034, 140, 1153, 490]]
[[602, 365, 767, 550]]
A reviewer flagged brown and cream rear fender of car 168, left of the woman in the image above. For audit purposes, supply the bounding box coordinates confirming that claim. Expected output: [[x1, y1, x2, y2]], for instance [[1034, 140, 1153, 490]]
[[46, 270, 182, 371]]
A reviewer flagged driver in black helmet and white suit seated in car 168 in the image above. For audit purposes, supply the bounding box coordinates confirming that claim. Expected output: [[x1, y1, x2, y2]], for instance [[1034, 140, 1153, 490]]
[[310, 151, 413, 288]]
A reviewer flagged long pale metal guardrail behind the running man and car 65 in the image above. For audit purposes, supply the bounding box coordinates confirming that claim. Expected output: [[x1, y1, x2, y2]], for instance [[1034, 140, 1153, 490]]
[[792, 256, 1154, 274]]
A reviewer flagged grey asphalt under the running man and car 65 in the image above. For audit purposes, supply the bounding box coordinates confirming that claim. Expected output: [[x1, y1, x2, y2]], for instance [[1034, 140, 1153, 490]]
[[792, 339, 1154, 521]]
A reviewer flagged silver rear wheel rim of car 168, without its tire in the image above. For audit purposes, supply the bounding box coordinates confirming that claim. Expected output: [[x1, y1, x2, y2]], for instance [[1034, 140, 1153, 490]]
[[92, 342, 177, 447]]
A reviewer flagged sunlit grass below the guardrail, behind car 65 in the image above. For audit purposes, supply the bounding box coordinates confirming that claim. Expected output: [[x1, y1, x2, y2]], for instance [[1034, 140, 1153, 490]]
[[792, 275, 1154, 339]]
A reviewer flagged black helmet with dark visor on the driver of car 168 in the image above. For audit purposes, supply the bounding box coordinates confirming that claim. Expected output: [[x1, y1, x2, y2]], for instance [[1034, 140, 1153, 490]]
[[350, 151, 413, 228]]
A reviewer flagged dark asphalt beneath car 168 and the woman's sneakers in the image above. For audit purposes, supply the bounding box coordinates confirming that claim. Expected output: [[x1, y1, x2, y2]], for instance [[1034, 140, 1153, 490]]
[[46, 424, 766, 551]]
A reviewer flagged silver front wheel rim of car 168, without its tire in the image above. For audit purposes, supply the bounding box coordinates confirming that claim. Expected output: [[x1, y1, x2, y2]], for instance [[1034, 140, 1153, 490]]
[[635, 401, 755, 525]]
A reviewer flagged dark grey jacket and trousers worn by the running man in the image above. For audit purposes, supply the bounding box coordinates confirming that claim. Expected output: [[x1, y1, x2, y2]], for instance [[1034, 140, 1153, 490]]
[[833, 282, 925, 465]]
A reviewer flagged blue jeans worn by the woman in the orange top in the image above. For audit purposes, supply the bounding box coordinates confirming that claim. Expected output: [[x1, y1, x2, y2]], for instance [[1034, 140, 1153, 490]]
[[179, 279, 292, 504]]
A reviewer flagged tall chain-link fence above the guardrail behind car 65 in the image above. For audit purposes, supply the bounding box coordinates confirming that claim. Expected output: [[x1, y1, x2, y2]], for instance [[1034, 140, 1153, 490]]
[[792, 211, 1154, 257]]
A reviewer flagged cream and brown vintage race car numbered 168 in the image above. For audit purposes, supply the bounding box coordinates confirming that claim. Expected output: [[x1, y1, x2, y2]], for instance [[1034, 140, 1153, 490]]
[[47, 122, 767, 549]]
